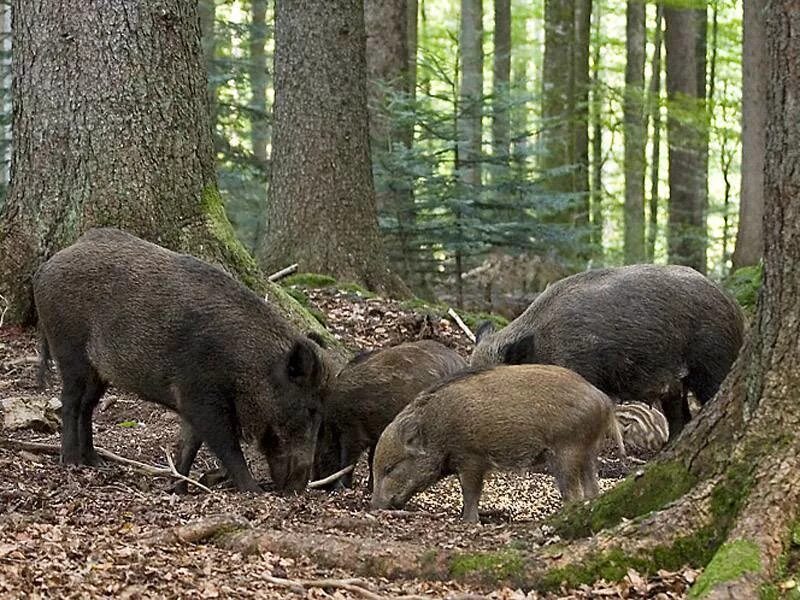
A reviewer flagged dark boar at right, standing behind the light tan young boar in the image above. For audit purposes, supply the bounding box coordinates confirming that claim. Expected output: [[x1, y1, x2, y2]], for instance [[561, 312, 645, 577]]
[[471, 265, 744, 439]]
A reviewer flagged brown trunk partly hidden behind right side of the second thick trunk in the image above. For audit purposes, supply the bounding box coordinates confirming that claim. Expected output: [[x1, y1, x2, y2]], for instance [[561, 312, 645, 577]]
[[364, 0, 415, 280]]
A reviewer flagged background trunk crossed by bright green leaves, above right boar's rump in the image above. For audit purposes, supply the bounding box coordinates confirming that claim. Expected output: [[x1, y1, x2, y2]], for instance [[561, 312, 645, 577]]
[[664, 7, 706, 273]]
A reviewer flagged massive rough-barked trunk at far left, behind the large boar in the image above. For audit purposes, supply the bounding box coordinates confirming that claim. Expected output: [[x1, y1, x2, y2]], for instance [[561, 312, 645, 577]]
[[0, 0, 268, 322]]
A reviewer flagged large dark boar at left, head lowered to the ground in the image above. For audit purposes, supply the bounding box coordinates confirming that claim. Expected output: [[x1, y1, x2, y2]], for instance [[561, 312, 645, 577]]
[[34, 229, 328, 491]]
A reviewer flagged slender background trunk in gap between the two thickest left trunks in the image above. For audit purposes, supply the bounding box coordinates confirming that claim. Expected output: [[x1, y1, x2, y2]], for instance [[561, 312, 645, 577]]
[[249, 0, 269, 173]]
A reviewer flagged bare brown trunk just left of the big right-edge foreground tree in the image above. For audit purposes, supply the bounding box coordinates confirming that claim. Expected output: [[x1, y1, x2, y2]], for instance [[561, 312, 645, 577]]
[[733, 0, 767, 269]]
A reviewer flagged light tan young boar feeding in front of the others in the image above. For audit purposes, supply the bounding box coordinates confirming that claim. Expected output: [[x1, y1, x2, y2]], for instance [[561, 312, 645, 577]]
[[372, 365, 625, 522]]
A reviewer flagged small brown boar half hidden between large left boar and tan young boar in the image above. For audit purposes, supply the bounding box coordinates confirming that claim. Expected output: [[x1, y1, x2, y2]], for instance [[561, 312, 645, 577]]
[[315, 340, 467, 487]]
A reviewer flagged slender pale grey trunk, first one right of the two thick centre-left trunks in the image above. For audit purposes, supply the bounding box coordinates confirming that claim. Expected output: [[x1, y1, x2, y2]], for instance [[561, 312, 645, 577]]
[[458, 0, 483, 190]]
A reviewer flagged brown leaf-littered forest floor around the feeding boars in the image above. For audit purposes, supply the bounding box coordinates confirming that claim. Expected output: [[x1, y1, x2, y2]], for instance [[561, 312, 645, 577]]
[[0, 290, 696, 599]]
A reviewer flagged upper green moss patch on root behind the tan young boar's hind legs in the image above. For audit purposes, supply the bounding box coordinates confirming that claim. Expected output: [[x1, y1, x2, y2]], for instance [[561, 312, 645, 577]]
[[550, 462, 697, 539]]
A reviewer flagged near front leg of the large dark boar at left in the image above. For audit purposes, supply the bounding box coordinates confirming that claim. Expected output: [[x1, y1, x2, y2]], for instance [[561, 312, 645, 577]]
[[181, 397, 263, 492]]
